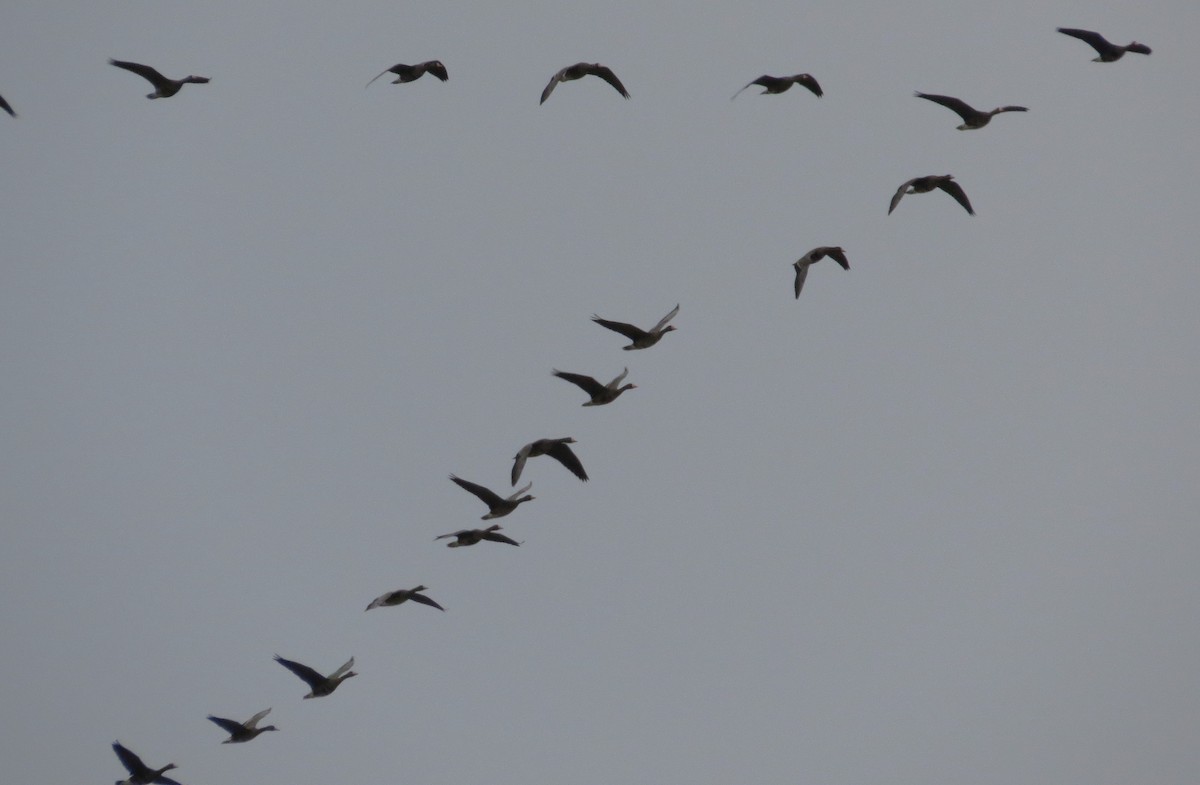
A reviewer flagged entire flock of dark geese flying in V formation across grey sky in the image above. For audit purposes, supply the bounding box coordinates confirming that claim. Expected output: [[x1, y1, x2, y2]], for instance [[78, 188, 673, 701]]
[[14, 21, 1132, 785]]
